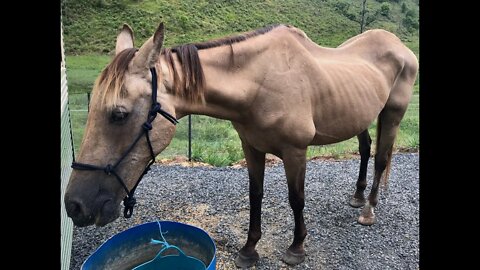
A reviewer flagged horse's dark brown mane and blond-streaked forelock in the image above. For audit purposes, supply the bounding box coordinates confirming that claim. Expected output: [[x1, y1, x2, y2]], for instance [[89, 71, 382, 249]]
[[94, 24, 290, 108]]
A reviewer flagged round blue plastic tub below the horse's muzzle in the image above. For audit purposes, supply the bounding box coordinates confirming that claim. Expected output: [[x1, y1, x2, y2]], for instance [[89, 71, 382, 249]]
[[82, 221, 217, 270]]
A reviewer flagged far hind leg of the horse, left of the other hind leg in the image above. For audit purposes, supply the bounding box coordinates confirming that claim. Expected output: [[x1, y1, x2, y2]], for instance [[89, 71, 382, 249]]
[[349, 129, 372, 208]]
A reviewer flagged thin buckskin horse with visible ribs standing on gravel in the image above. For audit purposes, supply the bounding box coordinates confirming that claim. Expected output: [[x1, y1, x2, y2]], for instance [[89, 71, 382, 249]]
[[65, 24, 418, 267]]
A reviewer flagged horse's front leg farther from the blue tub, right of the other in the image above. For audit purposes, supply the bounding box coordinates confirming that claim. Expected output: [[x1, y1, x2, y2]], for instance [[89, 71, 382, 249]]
[[282, 149, 307, 265]]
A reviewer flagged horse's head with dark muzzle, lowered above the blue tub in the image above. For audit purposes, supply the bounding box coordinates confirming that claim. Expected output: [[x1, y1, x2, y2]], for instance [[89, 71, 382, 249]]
[[64, 23, 175, 226]]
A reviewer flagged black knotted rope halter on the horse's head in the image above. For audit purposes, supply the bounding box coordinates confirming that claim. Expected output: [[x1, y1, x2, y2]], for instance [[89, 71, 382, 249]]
[[72, 68, 178, 218]]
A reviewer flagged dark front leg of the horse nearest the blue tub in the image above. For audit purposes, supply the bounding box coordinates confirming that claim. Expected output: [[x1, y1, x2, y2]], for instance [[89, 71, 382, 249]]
[[235, 141, 265, 268]]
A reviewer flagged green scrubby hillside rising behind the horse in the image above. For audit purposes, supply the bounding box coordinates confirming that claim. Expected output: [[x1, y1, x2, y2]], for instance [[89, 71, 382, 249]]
[[62, 0, 418, 55]]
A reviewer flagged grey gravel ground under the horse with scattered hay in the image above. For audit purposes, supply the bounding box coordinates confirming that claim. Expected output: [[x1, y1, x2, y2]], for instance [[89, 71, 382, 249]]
[[70, 153, 419, 269]]
